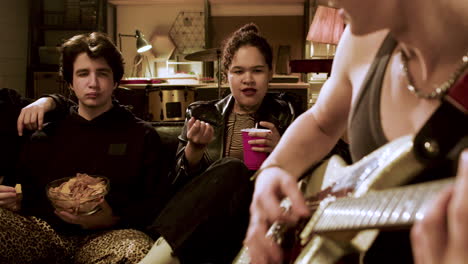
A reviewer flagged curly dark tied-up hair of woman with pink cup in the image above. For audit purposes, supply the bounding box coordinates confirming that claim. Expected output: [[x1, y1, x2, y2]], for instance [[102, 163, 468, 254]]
[[221, 23, 273, 81]]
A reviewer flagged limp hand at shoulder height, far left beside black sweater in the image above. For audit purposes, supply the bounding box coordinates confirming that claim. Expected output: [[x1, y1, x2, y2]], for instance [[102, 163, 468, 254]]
[[17, 97, 55, 136]]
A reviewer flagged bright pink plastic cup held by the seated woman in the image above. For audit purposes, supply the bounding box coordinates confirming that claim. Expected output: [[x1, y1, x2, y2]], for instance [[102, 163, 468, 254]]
[[241, 128, 271, 170]]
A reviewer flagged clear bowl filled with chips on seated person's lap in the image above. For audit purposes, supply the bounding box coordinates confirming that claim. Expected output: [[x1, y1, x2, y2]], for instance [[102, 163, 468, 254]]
[[46, 173, 109, 215]]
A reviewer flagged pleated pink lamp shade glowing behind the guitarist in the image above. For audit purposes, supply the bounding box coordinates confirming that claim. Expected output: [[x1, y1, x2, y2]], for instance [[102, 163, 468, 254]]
[[307, 6, 344, 45]]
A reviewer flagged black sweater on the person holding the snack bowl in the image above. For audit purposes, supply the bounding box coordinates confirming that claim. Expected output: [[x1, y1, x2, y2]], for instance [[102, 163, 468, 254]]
[[20, 104, 169, 233]]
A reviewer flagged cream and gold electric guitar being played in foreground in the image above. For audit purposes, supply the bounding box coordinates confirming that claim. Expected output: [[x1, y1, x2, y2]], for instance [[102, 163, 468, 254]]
[[233, 136, 450, 264]]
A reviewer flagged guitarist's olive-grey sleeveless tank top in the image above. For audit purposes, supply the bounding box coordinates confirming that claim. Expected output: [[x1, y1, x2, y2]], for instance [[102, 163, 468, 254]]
[[348, 35, 397, 162]]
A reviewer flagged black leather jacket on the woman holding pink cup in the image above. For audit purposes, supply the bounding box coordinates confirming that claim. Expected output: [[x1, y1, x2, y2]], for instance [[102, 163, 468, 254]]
[[171, 93, 295, 185]]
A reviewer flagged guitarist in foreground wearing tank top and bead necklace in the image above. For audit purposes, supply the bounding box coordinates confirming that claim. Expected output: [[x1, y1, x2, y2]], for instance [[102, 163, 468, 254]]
[[244, 0, 468, 264]]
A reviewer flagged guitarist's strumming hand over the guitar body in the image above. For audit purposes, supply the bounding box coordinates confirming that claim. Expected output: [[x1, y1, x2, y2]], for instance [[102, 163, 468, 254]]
[[244, 167, 310, 264]]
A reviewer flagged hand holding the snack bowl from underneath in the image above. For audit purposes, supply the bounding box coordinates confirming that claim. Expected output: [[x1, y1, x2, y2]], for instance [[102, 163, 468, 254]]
[[55, 199, 119, 229]]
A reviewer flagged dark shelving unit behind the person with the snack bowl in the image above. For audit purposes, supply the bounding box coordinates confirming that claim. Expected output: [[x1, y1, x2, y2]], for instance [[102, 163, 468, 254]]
[[26, 0, 107, 98]]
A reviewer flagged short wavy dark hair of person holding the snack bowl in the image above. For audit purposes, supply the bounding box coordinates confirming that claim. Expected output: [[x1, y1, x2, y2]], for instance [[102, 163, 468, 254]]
[[60, 32, 124, 84]]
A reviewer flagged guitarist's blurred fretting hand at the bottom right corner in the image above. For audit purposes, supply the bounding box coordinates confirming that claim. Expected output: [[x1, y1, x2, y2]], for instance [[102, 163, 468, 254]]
[[411, 149, 468, 264]]
